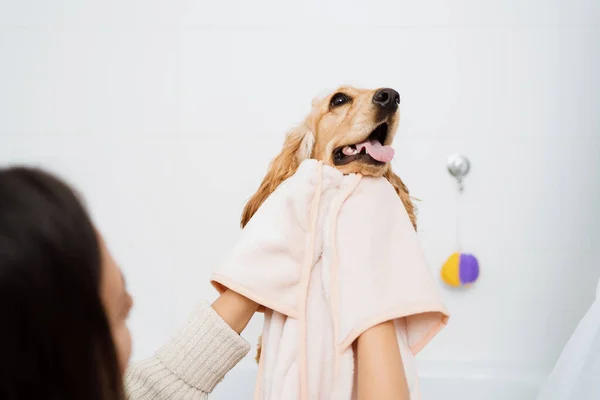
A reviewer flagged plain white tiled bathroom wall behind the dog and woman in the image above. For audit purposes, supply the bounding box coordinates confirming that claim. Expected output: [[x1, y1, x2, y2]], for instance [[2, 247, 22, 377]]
[[0, 0, 600, 394]]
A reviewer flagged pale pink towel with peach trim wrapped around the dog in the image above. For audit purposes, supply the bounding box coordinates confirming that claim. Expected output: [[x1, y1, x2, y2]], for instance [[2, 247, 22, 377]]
[[212, 160, 448, 400]]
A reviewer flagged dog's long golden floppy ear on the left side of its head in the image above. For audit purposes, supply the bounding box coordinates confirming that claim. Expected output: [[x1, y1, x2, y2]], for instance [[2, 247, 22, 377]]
[[240, 123, 315, 228]]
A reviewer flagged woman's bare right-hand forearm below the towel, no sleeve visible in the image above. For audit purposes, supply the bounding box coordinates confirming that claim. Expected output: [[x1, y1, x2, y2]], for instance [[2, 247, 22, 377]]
[[355, 321, 409, 400]]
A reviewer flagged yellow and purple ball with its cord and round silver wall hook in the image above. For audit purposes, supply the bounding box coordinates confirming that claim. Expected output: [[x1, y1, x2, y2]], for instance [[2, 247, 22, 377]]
[[441, 154, 479, 287]]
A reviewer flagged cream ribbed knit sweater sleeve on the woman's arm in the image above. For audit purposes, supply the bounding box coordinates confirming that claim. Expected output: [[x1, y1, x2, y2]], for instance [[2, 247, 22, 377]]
[[125, 304, 250, 400]]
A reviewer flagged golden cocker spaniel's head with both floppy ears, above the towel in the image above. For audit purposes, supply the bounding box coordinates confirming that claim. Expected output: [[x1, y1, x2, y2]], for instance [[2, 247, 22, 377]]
[[241, 86, 416, 227]]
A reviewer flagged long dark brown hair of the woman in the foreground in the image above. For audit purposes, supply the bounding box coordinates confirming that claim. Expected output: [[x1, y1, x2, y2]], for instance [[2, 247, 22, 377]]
[[0, 167, 124, 400]]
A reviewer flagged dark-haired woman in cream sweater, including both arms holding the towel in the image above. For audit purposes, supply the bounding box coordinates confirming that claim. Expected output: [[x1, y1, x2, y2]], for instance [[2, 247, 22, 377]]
[[0, 168, 408, 400]]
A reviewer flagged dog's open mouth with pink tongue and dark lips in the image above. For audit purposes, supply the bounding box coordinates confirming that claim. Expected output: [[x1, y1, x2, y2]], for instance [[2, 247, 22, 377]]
[[333, 122, 394, 165]]
